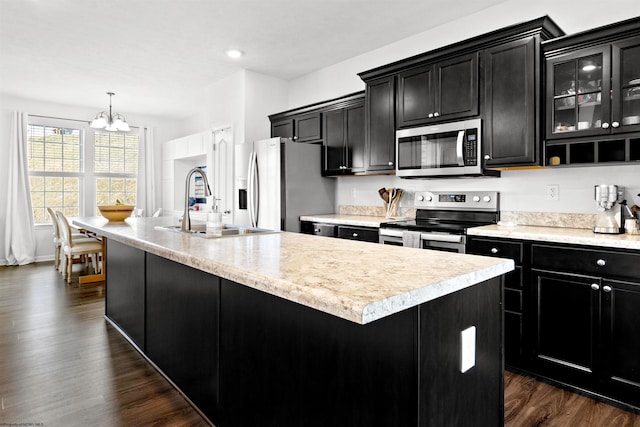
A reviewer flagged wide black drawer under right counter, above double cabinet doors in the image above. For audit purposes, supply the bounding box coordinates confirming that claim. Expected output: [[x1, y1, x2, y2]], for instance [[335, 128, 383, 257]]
[[531, 244, 640, 279]]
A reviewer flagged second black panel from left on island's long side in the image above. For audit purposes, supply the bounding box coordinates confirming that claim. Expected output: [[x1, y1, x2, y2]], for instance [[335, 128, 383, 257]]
[[145, 254, 220, 422]]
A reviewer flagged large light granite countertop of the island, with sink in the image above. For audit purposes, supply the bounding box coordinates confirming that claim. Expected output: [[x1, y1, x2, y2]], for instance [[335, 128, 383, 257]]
[[73, 217, 514, 324]]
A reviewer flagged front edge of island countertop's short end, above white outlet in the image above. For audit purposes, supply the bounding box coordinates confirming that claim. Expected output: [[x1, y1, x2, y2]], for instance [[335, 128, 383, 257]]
[[362, 259, 515, 324]]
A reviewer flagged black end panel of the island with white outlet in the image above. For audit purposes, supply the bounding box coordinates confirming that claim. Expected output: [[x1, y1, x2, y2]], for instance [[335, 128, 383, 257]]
[[420, 277, 504, 427]]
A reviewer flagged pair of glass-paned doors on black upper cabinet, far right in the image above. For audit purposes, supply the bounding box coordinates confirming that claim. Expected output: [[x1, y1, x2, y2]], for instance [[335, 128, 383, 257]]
[[546, 37, 640, 139]]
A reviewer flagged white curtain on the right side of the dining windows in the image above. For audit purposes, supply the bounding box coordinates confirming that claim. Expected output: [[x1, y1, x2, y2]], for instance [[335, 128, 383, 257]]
[[136, 127, 156, 216]]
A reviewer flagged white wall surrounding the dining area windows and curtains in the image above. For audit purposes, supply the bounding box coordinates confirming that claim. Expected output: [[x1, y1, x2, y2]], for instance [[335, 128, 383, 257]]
[[0, 95, 180, 265]]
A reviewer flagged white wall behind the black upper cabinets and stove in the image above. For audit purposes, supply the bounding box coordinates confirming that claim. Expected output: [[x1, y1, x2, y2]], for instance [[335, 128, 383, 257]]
[[288, 0, 640, 213]]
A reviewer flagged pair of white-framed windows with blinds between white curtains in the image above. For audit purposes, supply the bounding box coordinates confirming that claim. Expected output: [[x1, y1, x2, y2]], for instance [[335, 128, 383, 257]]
[[28, 118, 139, 224]]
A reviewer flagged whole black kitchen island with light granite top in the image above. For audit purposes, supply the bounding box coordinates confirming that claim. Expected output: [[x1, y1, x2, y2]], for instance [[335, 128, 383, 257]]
[[75, 218, 513, 427]]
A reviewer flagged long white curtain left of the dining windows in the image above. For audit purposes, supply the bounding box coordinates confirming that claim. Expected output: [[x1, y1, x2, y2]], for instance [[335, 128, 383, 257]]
[[4, 112, 36, 265]]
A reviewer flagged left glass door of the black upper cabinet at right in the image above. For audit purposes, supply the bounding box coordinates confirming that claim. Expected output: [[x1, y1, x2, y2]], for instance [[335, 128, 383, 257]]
[[547, 48, 610, 137]]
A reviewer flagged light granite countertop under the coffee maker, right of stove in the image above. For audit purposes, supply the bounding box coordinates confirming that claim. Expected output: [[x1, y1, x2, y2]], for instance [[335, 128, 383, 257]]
[[467, 225, 640, 250]]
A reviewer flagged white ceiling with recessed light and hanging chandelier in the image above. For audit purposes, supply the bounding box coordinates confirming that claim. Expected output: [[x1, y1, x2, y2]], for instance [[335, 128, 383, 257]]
[[0, 0, 504, 118]]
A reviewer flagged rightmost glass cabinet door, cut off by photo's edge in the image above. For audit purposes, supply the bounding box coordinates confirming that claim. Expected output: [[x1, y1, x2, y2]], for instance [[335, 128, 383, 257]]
[[612, 38, 640, 132]]
